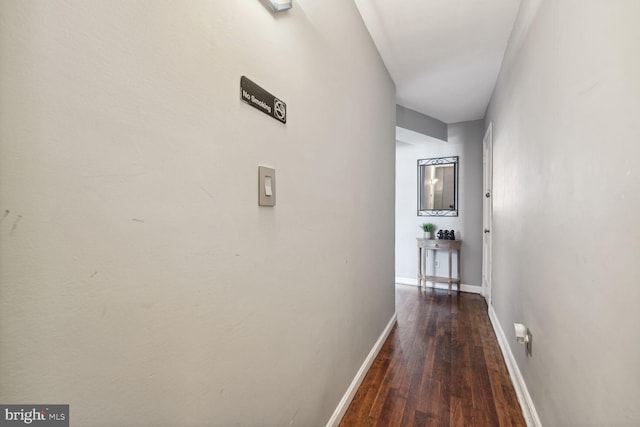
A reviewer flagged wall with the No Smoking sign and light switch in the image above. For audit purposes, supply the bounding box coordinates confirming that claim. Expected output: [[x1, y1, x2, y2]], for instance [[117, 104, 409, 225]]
[[0, 0, 395, 426]]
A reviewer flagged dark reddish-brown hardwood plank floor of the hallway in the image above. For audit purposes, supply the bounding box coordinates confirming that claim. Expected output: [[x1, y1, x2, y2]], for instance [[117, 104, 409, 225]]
[[340, 285, 526, 427]]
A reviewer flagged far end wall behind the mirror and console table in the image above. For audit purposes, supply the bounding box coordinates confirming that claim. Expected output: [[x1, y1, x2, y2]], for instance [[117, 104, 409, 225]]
[[396, 120, 484, 291]]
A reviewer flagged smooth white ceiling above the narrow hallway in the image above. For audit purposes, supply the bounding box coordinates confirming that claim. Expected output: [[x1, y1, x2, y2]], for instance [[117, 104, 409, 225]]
[[355, 0, 520, 123]]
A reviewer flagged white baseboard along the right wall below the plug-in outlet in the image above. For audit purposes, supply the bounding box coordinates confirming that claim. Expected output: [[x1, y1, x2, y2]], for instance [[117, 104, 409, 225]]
[[489, 305, 542, 427]]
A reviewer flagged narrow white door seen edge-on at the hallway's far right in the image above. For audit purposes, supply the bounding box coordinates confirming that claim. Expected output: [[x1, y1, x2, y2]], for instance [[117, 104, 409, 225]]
[[482, 123, 493, 306]]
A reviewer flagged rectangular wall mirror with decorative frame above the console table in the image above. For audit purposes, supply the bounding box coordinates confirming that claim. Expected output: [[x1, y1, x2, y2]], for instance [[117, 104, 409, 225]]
[[418, 156, 458, 216]]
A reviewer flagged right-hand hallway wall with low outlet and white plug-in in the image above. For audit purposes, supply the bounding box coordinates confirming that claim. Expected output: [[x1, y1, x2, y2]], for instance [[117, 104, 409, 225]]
[[486, 0, 640, 426]]
